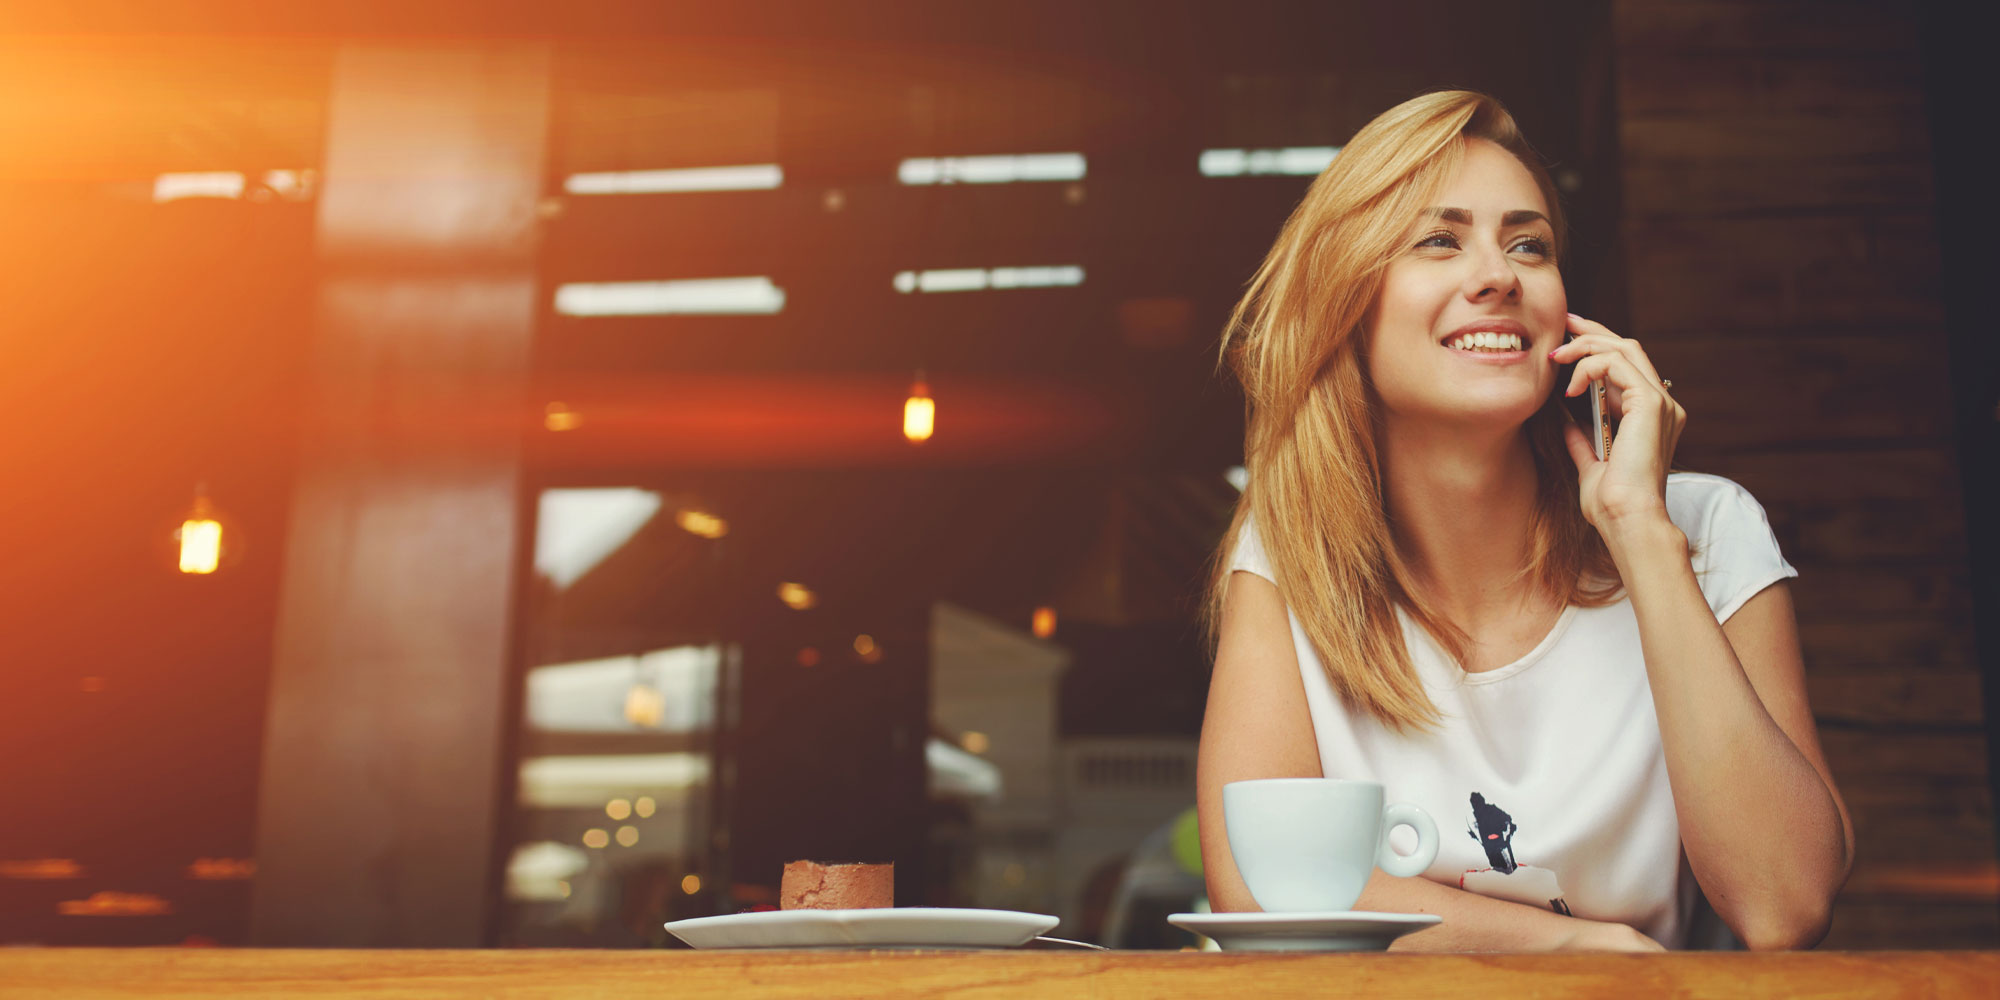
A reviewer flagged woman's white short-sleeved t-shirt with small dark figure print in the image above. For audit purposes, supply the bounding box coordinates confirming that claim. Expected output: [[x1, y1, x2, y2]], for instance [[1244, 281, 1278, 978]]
[[1230, 472, 1798, 948]]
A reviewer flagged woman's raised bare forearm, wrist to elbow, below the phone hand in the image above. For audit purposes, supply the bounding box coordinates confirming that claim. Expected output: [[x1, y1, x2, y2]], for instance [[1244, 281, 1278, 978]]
[[1606, 524, 1848, 948]]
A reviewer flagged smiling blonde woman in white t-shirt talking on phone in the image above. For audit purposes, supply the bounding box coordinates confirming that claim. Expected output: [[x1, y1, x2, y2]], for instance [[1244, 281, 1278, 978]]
[[1196, 92, 1854, 950]]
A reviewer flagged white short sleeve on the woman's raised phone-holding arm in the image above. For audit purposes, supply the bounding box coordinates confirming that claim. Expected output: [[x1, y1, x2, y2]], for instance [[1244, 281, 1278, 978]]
[[1666, 472, 1798, 622]]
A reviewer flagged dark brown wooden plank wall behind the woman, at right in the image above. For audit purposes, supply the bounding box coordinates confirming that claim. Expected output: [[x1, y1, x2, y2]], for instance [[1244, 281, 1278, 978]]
[[1614, 0, 2000, 948]]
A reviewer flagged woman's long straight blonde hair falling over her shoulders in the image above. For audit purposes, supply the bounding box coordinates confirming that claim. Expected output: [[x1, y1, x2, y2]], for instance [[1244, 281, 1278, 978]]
[[1206, 90, 1622, 732]]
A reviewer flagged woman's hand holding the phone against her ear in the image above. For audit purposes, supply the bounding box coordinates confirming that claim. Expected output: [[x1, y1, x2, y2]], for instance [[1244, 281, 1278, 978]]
[[1548, 312, 1688, 534]]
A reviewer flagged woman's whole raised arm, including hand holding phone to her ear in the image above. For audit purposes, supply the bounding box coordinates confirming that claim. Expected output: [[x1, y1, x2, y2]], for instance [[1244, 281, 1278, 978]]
[[1550, 314, 1854, 948]]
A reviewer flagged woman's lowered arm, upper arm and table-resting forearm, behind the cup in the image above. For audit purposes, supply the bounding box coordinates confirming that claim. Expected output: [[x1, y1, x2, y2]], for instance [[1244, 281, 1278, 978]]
[[1194, 572, 1658, 952]]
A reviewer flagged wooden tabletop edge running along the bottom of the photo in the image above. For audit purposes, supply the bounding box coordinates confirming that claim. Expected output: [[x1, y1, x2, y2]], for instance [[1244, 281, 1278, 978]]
[[0, 948, 2000, 1000]]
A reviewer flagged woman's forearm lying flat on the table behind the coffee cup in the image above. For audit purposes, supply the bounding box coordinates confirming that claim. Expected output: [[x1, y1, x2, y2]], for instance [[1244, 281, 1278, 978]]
[[1354, 870, 1640, 952]]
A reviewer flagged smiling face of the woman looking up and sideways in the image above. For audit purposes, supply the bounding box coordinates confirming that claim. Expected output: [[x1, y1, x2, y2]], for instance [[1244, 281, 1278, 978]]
[[1364, 140, 1570, 428]]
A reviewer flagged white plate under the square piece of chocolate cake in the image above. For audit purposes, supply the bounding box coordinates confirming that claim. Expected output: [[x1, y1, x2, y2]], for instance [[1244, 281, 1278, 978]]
[[666, 906, 1056, 948]]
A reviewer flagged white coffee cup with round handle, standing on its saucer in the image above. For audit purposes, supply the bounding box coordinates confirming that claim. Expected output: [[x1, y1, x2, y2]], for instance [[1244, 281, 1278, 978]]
[[1222, 778, 1438, 912]]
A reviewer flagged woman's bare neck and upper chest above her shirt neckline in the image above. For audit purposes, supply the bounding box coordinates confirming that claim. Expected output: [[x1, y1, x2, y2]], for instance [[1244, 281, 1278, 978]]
[[1378, 422, 1546, 628]]
